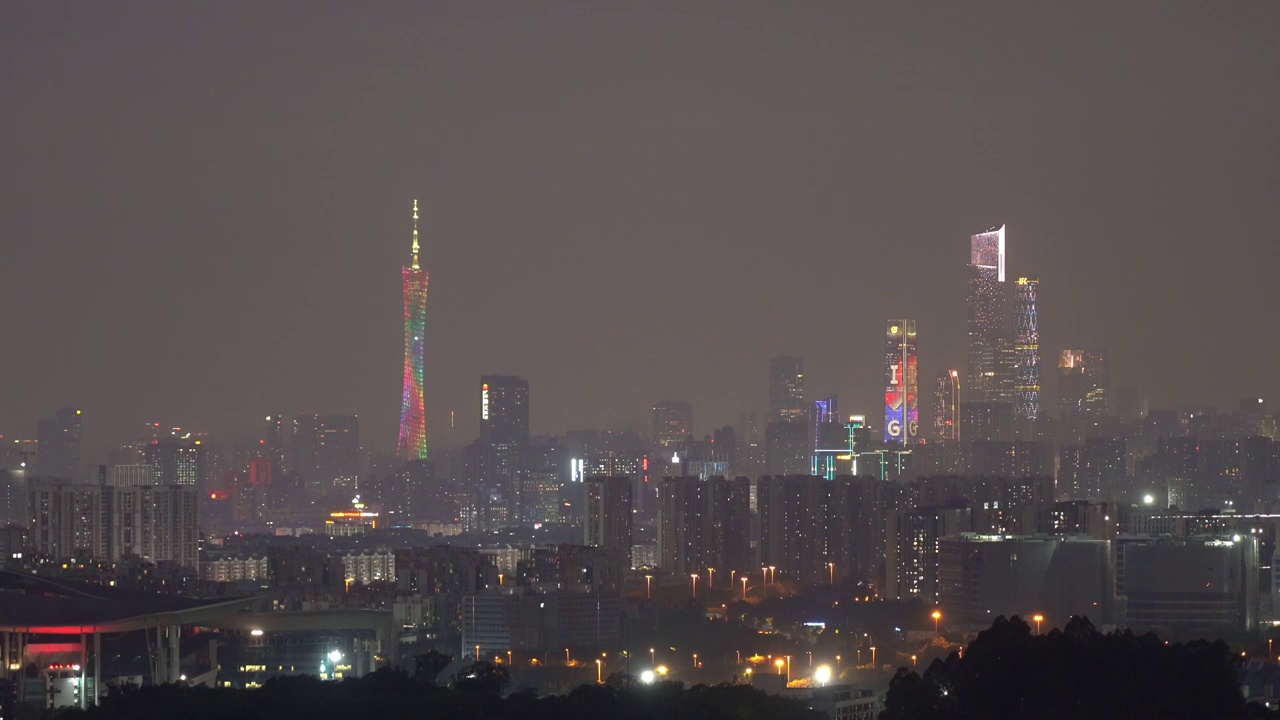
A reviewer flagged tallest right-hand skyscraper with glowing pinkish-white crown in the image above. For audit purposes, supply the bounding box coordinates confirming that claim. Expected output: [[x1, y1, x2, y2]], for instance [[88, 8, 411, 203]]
[[965, 225, 1006, 401]]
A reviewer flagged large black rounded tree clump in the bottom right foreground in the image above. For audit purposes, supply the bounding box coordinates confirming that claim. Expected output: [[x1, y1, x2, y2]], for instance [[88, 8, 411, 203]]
[[881, 609, 1247, 720]]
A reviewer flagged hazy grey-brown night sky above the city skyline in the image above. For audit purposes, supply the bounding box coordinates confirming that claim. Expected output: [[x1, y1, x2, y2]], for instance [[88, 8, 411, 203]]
[[0, 0, 1280, 448]]
